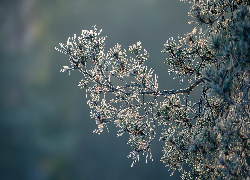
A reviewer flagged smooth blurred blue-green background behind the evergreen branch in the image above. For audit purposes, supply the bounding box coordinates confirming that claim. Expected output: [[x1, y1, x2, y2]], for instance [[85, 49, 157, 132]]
[[0, 0, 198, 180]]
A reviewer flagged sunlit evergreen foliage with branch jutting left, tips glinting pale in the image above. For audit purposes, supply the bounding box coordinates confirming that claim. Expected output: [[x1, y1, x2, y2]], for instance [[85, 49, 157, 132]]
[[56, 0, 250, 179]]
